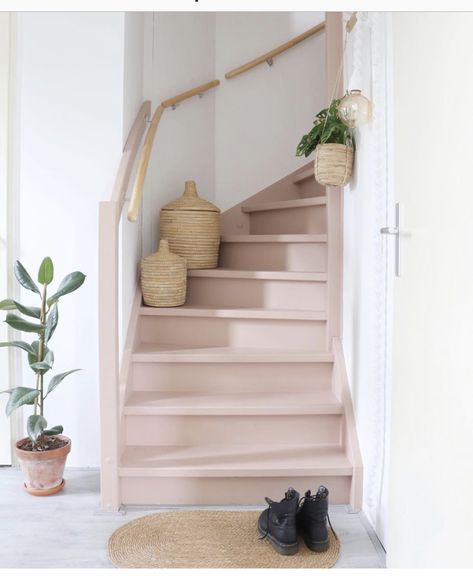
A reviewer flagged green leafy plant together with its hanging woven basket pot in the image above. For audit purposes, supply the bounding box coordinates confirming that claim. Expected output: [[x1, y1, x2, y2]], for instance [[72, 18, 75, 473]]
[[296, 99, 355, 186]]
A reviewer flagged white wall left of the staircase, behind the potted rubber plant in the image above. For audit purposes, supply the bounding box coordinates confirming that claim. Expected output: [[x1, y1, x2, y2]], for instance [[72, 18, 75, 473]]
[[18, 12, 124, 466]]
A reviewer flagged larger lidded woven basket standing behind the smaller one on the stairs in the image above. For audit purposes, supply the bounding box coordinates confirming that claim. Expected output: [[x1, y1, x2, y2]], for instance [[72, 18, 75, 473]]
[[159, 181, 220, 269]]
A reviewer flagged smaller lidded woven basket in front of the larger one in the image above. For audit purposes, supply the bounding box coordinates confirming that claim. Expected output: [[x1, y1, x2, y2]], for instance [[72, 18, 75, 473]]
[[141, 239, 187, 307]]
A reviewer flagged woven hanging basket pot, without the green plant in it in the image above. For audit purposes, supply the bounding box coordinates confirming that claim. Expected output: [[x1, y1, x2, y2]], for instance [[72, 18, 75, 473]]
[[314, 143, 353, 186]]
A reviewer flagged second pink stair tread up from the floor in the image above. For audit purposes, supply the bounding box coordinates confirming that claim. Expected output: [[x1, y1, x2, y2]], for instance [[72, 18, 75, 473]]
[[124, 389, 343, 415]]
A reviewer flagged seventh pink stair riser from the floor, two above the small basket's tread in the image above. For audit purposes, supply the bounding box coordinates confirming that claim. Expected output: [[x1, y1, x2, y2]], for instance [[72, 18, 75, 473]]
[[250, 205, 327, 234]]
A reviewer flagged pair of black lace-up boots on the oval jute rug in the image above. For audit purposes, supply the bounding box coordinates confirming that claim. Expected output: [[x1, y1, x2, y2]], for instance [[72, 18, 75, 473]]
[[258, 485, 336, 556]]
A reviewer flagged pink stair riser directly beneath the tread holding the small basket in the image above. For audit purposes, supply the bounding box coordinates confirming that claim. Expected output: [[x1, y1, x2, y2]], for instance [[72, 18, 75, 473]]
[[140, 316, 326, 351]]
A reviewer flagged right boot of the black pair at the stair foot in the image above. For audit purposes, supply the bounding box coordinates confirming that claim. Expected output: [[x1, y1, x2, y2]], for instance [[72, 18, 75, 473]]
[[297, 485, 337, 552]]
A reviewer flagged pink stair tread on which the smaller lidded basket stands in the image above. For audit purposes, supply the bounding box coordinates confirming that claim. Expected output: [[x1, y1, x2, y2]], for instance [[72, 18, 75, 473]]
[[140, 304, 327, 321]]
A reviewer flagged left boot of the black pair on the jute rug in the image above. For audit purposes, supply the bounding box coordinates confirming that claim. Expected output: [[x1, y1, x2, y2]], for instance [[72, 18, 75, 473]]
[[258, 487, 299, 556]]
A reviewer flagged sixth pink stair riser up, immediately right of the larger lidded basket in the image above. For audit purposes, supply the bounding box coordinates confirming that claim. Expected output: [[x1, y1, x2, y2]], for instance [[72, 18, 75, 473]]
[[219, 242, 327, 273]]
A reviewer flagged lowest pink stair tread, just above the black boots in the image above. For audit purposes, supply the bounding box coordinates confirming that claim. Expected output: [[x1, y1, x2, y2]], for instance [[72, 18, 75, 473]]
[[119, 444, 353, 477]]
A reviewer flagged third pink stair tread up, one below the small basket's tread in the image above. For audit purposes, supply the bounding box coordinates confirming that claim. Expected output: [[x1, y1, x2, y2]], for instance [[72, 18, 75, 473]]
[[132, 343, 333, 363]]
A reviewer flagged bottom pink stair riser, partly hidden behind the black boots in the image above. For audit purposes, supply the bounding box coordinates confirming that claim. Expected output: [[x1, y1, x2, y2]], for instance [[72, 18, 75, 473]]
[[121, 475, 351, 507]]
